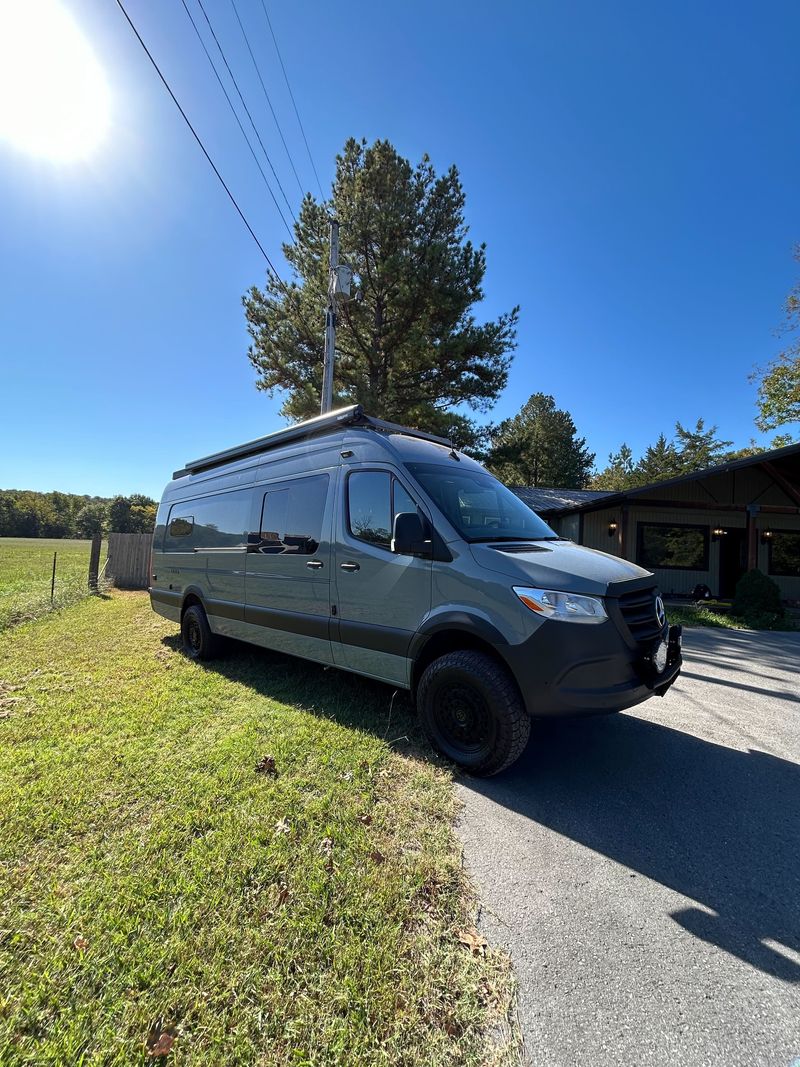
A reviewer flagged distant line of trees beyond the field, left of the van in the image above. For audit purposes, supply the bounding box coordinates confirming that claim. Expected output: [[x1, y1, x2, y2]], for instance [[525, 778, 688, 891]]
[[0, 489, 157, 538]]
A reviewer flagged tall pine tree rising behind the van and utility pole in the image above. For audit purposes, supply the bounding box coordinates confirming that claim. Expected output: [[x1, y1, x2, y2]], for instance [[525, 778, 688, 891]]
[[243, 139, 518, 446]]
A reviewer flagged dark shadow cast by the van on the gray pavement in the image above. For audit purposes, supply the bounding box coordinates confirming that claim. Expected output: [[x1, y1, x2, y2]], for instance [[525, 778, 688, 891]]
[[462, 715, 800, 982]]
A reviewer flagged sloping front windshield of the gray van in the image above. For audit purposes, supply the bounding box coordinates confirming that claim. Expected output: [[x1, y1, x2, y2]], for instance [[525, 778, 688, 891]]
[[407, 463, 558, 541]]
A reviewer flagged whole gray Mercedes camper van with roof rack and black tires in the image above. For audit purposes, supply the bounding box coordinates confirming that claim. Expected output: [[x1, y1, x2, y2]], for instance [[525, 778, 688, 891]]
[[150, 404, 681, 775]]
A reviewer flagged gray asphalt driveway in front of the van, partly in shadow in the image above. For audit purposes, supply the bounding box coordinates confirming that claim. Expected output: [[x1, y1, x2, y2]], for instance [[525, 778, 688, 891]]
[[459, 630, 800, 1067]]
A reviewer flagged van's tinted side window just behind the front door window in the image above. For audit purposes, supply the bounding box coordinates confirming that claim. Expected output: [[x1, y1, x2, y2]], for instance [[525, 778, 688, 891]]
[[259, 474, 329, 556]]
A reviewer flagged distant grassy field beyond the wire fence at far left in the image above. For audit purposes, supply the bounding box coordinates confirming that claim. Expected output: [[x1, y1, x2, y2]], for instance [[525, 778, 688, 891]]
[[0, 537, 101, 630]]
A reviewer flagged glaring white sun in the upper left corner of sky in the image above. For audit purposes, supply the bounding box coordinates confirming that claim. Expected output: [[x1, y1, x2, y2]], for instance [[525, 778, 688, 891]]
[[0, 0, 111, 163]]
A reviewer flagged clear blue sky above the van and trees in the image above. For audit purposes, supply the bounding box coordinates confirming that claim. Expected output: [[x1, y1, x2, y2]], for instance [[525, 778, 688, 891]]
[[0, 0, 800, 496]]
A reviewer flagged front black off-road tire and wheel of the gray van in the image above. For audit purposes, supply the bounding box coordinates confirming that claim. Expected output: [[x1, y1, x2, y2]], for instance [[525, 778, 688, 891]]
[[417, 650, 530, 777]]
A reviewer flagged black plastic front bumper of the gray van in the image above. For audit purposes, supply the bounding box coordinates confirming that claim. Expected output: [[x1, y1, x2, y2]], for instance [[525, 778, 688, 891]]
[[497, 620, 683, 718]]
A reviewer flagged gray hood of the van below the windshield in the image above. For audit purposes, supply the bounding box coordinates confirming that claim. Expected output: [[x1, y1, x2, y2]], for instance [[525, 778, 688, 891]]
[[469, 541, 653, 596]]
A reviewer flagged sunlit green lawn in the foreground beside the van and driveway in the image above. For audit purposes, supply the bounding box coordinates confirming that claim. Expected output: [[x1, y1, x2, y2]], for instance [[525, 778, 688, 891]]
[[0, 593, 516, 1067]]
